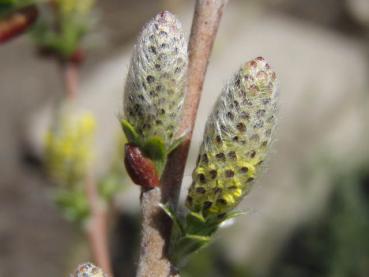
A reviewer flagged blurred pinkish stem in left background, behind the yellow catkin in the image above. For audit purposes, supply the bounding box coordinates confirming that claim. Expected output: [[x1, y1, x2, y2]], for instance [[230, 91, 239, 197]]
[[64, 62, 112, 276]]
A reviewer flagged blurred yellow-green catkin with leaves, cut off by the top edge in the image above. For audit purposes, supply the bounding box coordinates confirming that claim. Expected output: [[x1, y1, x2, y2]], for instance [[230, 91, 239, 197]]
[[33, 0, 94, 59]]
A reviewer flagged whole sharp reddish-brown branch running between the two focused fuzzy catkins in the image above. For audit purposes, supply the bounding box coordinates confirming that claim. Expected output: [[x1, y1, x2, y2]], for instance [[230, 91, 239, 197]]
[[137, 0, 227, 277]]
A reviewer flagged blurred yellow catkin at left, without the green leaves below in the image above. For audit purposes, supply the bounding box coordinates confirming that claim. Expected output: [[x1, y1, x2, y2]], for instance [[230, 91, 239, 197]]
[[45, 108, 96, 185]]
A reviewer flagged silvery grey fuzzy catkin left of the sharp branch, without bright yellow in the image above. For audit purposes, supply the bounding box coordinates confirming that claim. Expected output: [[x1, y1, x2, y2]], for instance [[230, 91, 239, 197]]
[[124, 12, 187, 147]]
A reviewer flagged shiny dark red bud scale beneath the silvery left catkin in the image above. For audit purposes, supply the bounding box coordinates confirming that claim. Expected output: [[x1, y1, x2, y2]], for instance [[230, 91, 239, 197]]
[[124, 143, 160, 189]]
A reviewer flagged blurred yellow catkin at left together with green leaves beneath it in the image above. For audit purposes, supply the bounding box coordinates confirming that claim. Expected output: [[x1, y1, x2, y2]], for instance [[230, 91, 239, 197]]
[[45, 106, 96, 223]]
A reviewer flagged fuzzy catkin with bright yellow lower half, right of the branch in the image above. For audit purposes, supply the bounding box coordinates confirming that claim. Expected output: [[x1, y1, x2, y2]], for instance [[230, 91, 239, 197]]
[[186, 57, 278, 217]]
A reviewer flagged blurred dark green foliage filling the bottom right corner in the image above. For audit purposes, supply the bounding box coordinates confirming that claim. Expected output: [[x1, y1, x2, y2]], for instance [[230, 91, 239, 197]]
[[267, 165, 369, 277]]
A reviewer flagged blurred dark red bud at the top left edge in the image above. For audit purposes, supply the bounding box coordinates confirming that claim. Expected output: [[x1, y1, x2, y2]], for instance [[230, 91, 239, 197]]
[[0, 5, 38, 44]]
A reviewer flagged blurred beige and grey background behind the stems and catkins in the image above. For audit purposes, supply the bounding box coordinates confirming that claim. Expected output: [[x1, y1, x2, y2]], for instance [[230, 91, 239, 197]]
[[0, 0, 369, 277]]
